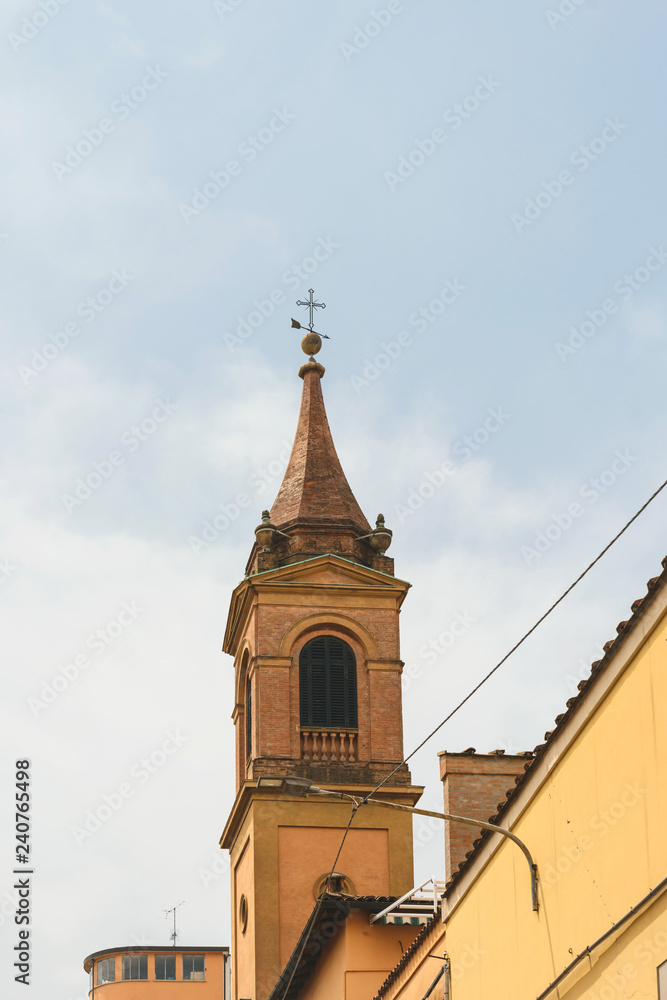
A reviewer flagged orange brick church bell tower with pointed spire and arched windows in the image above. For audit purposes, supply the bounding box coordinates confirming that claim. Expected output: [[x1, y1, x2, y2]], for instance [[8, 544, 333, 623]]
[[220, 316, 422, 1000]]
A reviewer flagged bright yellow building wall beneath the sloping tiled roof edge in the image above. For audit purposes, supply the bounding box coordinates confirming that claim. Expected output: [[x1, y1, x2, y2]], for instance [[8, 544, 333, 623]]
[[438, 600, 667, 1000]]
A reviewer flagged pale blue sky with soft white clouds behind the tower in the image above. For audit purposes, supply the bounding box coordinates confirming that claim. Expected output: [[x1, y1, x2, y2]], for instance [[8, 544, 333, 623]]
[[0, 0, 667, 1000]]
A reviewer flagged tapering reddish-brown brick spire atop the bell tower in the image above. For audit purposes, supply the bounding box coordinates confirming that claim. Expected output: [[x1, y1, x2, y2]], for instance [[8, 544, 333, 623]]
[[271, 360, 371, 536]]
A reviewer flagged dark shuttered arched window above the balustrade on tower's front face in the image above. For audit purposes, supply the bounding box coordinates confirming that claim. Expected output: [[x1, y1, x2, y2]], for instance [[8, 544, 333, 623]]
[[299, 635, 357, 729]]
